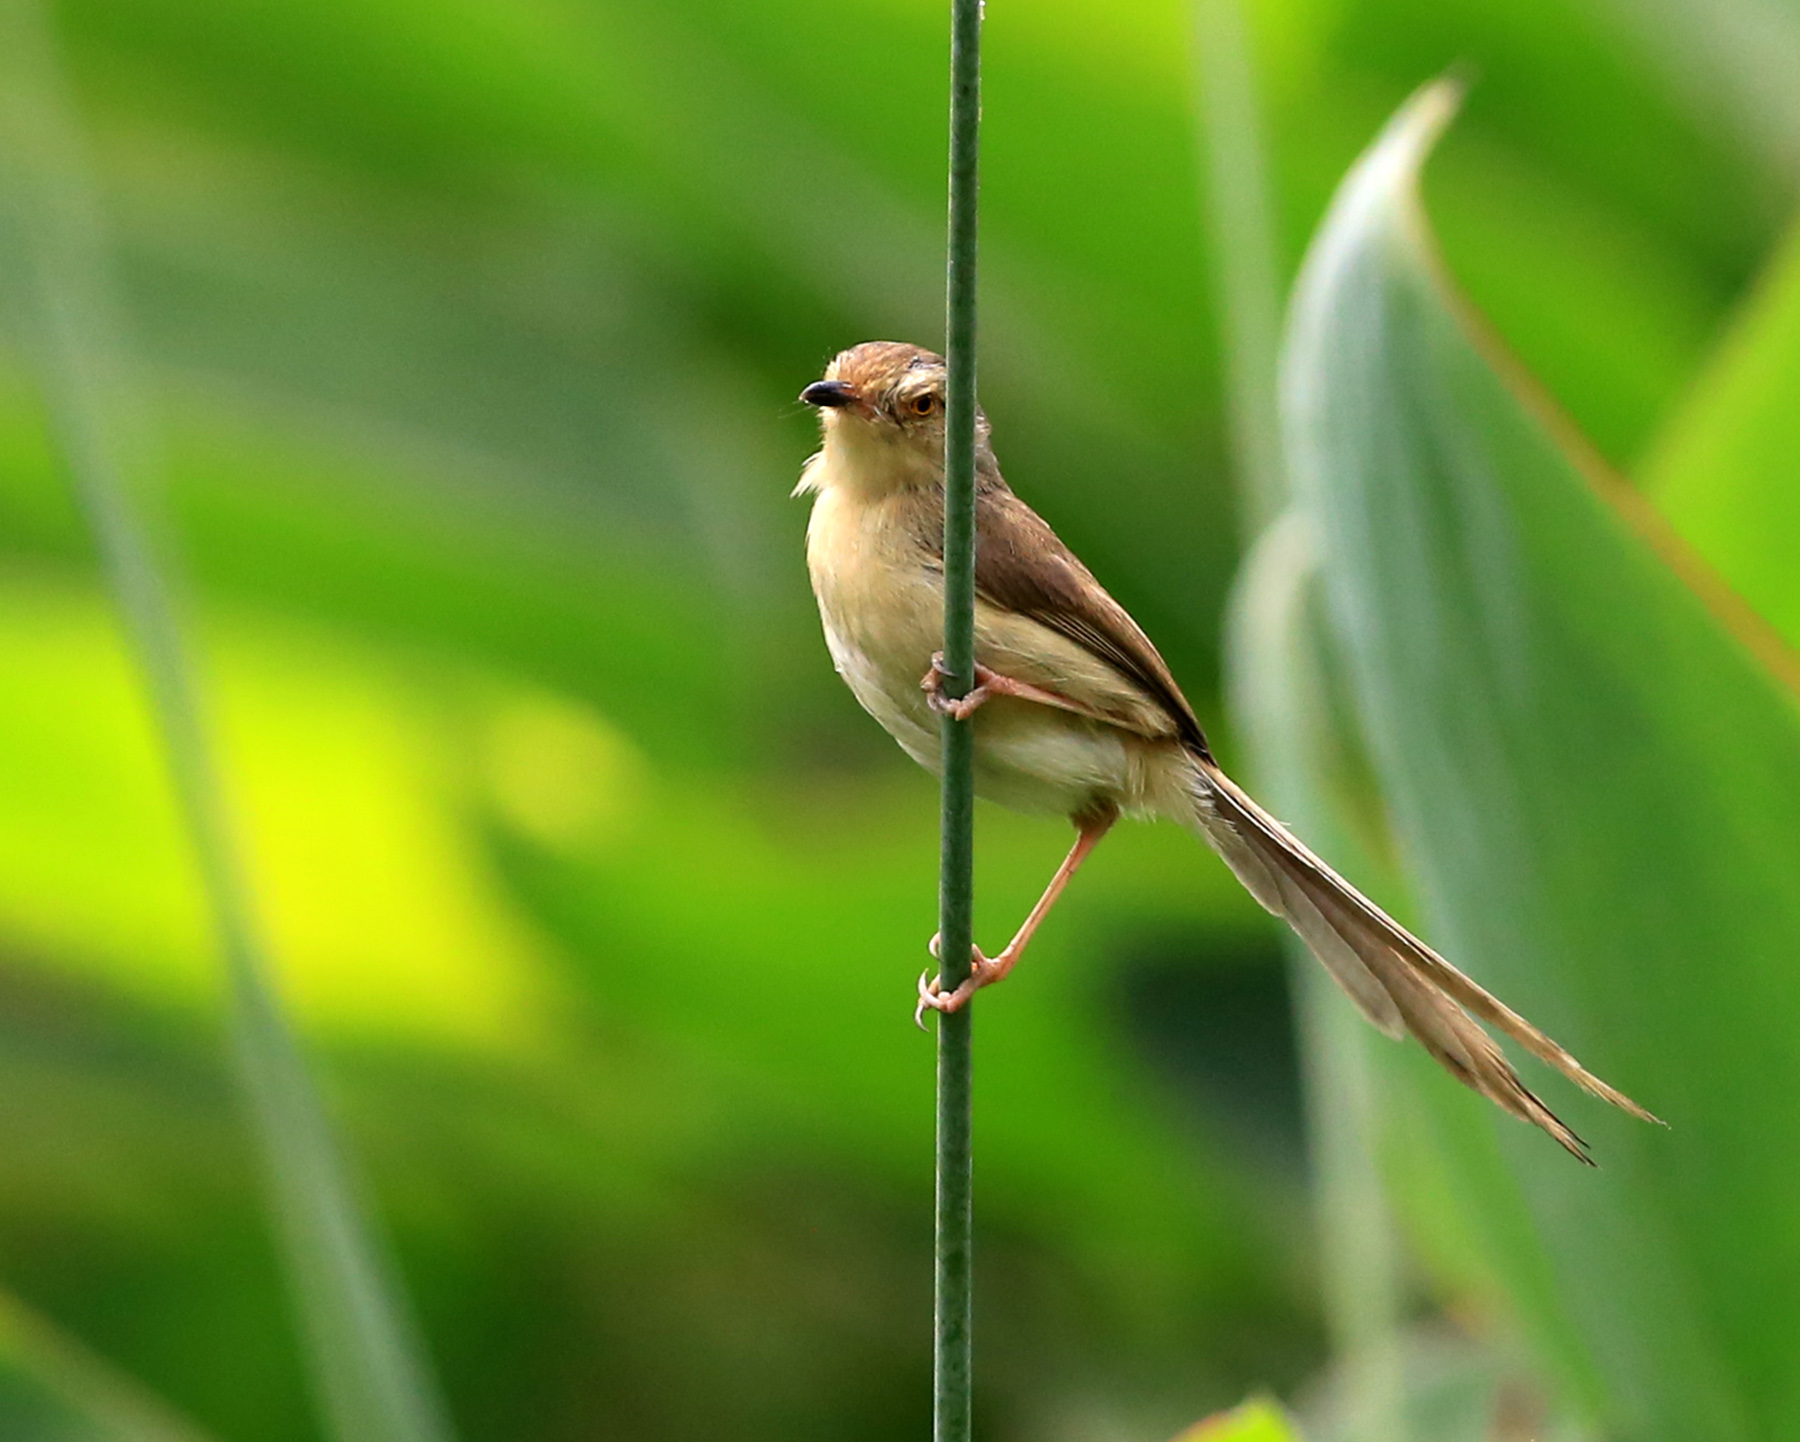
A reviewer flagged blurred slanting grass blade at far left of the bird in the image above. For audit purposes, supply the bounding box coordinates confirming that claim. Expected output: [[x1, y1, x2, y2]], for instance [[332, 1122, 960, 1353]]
[[0, 0, 450, 1442]]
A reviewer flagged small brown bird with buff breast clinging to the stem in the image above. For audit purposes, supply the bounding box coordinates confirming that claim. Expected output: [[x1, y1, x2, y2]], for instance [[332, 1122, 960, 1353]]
[[796, 340, 1656, 1161]]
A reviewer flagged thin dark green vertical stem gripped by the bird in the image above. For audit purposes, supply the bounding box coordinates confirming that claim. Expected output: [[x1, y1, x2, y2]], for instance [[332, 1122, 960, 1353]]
[[932, 0, 981, 1442]]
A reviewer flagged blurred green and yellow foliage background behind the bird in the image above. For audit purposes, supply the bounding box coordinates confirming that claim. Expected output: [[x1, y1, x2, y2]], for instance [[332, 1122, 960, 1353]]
[[0, 0, 1800, 1442]]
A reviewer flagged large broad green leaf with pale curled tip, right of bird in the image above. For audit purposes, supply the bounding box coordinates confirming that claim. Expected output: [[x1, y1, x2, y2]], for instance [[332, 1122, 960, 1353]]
[[1283, 86, 1800, 1438]]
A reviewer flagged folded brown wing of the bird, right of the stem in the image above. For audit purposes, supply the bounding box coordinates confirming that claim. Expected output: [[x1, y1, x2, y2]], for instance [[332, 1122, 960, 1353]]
[[964, 475, 1211, 760]]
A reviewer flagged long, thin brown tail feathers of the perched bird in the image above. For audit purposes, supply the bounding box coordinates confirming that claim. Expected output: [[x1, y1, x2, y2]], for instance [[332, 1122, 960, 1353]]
[[1193, 758, 1656, 1165]]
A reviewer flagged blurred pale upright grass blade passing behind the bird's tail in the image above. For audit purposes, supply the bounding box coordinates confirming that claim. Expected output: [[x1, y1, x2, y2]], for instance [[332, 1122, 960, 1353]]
[[1193, 0, 1406, 1442]]
